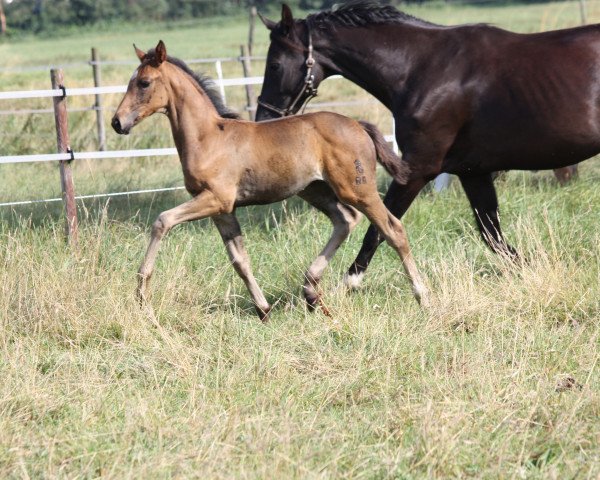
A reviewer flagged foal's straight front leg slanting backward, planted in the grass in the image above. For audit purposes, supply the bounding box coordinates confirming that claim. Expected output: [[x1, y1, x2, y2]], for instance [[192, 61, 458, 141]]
[[212, 214, 271, 322]]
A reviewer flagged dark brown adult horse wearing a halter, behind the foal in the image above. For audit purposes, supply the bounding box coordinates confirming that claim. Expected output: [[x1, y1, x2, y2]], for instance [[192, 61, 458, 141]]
[[256, 1, 600, 285]]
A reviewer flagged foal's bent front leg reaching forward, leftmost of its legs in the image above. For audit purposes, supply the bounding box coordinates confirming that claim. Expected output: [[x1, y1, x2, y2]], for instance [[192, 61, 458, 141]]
[[137, 190, 223, 303]]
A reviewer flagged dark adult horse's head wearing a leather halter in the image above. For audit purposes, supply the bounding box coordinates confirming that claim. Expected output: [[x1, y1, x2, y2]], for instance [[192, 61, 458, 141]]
[[256, 4, 327, 121]]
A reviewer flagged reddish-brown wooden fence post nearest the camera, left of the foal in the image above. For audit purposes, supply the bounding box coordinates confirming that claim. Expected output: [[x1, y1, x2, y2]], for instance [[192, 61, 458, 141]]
[[50, 69, 78, 246]]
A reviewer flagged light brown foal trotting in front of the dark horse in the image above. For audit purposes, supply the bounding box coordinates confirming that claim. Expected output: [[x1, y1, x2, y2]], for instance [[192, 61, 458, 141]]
[[112, 41, 427, 320]]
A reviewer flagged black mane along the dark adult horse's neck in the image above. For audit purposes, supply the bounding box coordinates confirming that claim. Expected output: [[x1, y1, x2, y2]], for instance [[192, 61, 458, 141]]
[[305, 0, 434, 28]]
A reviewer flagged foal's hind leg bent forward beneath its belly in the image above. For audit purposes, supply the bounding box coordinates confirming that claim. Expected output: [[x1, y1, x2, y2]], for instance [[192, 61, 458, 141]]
[[298, 182, 361, 314]]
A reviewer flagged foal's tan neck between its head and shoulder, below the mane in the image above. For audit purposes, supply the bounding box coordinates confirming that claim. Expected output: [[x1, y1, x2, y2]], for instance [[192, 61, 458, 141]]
[[168, 73, 220, 162]]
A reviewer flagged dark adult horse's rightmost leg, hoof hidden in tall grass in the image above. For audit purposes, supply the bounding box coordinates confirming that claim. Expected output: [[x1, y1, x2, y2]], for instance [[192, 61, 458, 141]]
[[459, 173, 519, 260]]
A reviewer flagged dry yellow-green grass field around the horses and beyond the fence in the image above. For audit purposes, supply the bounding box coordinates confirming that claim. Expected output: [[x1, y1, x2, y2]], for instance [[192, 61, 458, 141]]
[[0, 2, 600, 479]]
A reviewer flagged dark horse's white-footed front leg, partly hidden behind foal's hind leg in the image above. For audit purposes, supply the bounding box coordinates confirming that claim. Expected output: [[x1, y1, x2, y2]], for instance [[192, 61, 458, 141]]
[[346, 178, 427, 288]]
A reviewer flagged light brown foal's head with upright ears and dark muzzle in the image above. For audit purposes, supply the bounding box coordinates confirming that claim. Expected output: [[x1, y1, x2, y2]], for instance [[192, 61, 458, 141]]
[[111, 40, 169, 135]]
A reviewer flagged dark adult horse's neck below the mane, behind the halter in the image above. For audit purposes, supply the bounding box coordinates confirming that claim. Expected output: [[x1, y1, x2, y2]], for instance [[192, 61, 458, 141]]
[[322, 24, 429, 109]]
